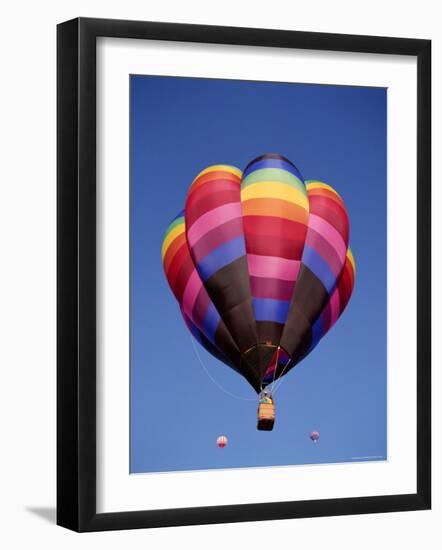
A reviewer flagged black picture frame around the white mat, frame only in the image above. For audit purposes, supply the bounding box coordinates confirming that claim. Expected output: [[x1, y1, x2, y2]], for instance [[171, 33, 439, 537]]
[[57, 18, 431, 531]]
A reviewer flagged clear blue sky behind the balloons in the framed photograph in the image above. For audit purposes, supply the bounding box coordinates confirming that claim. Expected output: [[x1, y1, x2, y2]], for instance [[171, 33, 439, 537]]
[[130, 76, 387, 472]]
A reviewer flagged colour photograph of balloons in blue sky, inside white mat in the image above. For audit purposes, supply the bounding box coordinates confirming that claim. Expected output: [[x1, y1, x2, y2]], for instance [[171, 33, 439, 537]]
[[129, 74, 388, 474]]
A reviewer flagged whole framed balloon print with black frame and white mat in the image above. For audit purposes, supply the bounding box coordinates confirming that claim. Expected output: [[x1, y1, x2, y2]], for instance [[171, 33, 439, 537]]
[[57, 18, 431, 531]]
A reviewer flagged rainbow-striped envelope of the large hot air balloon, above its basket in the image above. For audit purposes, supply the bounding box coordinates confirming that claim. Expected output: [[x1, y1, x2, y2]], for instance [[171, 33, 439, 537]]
[[162, 154, 355, 430]]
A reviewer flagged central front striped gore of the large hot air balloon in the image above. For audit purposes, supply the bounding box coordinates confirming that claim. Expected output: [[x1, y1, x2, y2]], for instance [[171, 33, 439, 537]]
[[241, 155, 309, 342]]
